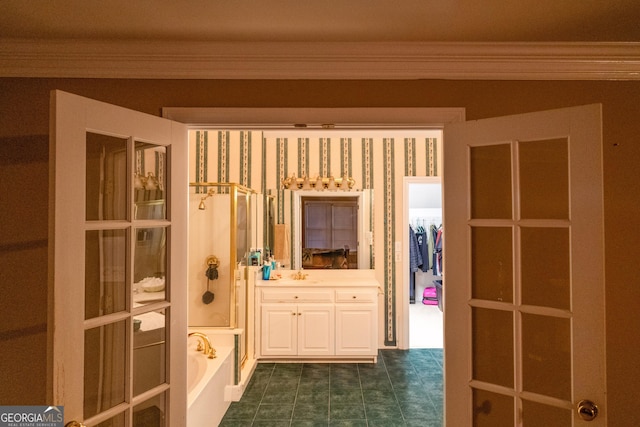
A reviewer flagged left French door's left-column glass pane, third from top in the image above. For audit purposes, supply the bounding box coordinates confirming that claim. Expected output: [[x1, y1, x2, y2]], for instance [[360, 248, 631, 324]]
[[84, 320, 127, 418]]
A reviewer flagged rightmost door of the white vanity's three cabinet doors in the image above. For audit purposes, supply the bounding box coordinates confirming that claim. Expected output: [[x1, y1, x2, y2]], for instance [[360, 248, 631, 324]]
[[336, 304, 378, 356]]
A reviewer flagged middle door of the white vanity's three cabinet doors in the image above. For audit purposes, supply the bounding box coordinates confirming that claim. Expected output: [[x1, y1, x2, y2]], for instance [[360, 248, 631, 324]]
[[296, 304, 335, 356]]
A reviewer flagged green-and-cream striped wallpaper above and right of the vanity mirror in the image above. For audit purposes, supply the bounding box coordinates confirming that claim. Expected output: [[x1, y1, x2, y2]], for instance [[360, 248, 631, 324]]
[[189, 130, 441, 346]]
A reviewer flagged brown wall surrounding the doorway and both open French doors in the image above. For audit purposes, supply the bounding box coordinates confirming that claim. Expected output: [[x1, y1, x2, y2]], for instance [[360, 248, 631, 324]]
[[0, 79, 640, 426]]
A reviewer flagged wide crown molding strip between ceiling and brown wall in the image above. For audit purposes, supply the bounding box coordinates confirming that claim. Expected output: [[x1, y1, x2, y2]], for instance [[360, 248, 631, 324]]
[[0, 39, 640, 80]]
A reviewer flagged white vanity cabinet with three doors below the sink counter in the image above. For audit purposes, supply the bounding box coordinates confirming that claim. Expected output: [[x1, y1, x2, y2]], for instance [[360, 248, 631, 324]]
[[256, 281, 378, 361]]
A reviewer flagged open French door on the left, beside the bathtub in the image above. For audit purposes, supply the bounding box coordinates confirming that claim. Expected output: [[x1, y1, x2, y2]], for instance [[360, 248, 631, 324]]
[[48, 91, 188, 427]]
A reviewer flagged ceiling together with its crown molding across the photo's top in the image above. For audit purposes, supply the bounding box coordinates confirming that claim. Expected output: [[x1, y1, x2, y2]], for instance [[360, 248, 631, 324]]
[[0, 0, 640, 80]]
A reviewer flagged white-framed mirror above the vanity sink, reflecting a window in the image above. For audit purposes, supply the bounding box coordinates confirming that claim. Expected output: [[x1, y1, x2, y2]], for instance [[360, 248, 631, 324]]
[[279, 190, 374, 270]]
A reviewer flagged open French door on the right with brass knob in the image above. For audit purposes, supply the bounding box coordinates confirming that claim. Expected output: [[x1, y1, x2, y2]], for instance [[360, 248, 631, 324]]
[[443, 105, 607, 427]]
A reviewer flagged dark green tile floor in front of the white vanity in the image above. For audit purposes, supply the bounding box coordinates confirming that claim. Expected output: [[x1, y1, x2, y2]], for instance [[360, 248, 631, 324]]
[[220, 349, 443, 427]]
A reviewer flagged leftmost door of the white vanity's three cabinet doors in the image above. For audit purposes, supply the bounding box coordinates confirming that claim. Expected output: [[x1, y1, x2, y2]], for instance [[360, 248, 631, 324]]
[[260, 304, 298, 356]]
